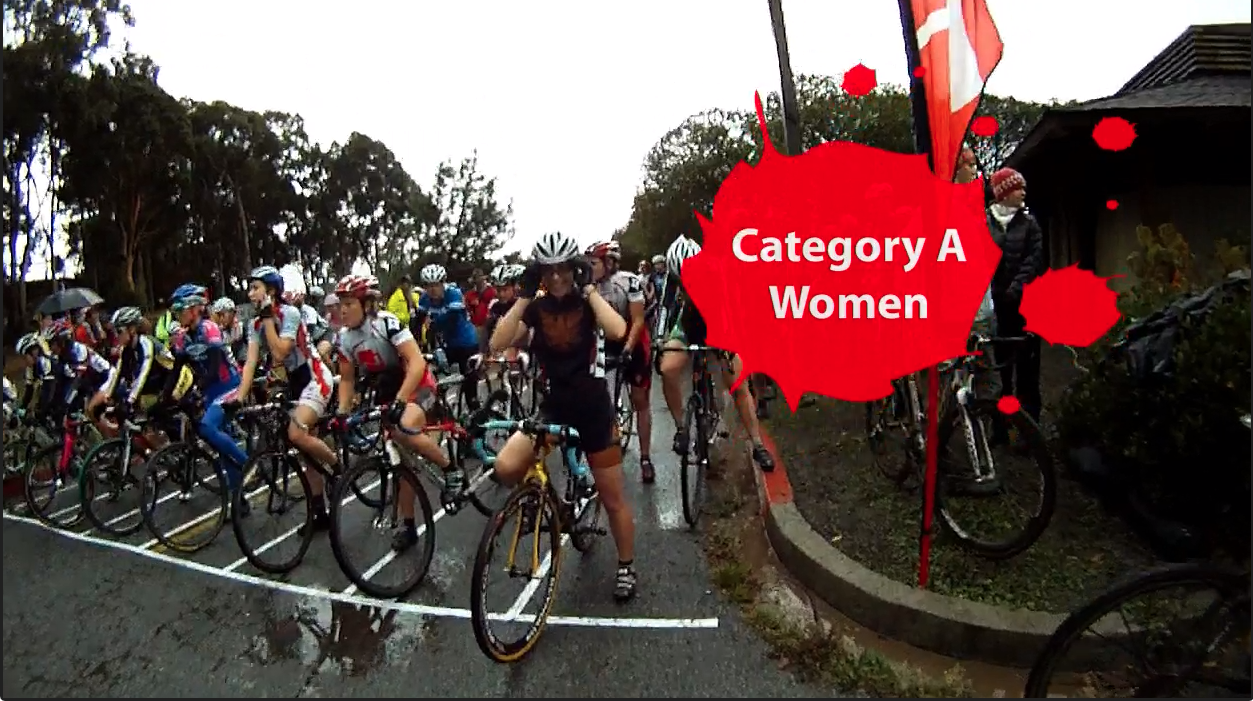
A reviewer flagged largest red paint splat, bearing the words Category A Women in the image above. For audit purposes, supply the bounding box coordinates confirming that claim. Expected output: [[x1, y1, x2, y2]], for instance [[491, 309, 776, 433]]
[[680, 95, 1001, 410]]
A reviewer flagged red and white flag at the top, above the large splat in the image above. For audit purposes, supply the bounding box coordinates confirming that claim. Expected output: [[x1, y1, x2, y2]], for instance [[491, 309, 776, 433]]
[[908, 0, 1005, 181]]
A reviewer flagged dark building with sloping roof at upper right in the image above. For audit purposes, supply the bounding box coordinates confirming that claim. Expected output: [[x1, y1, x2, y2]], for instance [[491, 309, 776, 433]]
[[1005, 24, 1253, 285]]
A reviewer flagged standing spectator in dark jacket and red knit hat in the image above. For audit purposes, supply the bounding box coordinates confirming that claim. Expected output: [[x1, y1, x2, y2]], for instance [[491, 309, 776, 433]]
[[987, 168, 1046, 421]]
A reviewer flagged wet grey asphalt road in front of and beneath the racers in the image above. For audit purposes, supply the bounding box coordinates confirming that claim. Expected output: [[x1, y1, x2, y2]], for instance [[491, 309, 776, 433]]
[[3, 386, 829, 698]]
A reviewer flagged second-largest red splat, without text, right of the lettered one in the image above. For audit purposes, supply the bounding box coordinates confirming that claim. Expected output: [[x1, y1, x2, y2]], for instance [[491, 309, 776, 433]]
[[1019, 263, 1121, 347]]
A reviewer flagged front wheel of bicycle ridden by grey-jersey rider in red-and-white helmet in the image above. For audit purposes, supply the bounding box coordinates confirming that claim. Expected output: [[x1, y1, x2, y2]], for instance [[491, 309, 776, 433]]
[[331, 456, 435, 598]]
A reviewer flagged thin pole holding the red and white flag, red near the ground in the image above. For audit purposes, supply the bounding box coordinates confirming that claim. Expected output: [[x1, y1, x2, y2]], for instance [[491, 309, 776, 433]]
[[896, 0, 940, 589]]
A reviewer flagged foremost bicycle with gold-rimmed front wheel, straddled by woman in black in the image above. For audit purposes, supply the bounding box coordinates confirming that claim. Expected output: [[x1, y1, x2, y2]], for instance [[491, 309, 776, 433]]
[[470, 419, 605, 663]]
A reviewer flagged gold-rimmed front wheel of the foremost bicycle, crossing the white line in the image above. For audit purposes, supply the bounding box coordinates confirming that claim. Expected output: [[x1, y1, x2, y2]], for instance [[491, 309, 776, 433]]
[[470, 482, 561, 663]]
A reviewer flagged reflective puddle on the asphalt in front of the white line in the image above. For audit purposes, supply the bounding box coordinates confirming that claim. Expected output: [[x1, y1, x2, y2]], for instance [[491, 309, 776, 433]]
[[246, 594, 435, 677]]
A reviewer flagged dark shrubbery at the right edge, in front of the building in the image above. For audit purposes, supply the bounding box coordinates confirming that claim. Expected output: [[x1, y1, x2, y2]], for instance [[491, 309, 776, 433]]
[[1058, 224, 1253, 553]]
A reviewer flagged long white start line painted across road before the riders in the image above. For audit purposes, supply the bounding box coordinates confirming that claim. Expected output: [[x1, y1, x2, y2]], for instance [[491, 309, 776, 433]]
[[4, 513, 718, 630]]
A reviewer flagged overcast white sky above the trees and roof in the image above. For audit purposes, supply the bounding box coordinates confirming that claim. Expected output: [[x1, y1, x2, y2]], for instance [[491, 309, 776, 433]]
[[19, 0, 1249, 279]]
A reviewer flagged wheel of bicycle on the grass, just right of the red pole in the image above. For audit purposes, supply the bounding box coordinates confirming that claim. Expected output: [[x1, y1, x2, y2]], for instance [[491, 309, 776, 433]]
[[936, 399, 1058, 559]]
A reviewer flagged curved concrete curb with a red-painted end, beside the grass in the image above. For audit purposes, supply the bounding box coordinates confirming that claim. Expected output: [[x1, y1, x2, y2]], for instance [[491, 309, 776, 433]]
[[753, 429, 1065, 668]]
